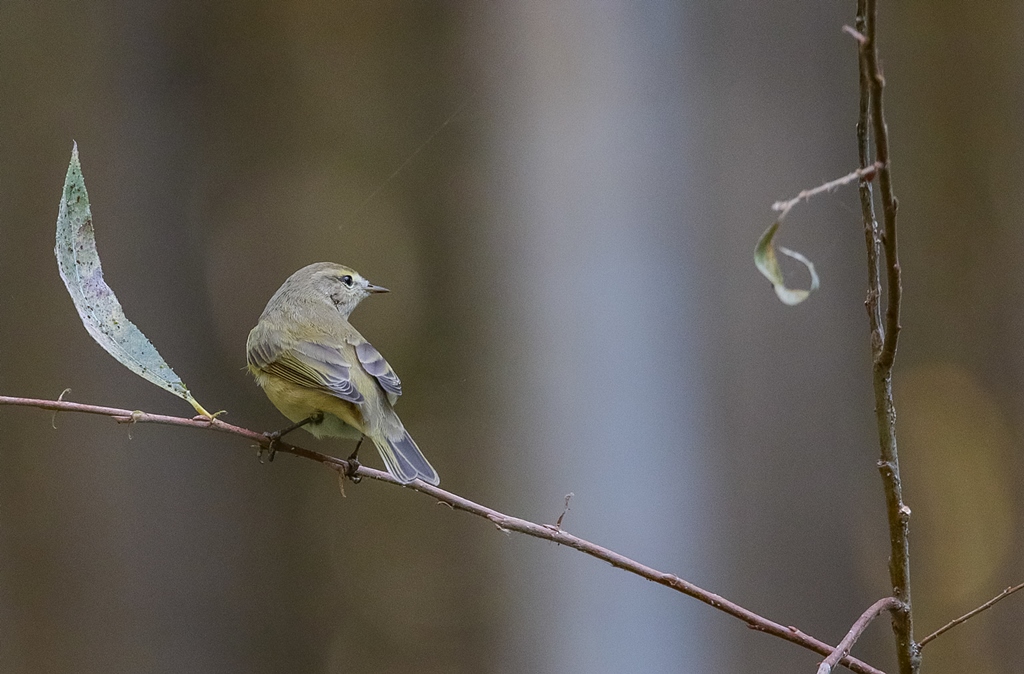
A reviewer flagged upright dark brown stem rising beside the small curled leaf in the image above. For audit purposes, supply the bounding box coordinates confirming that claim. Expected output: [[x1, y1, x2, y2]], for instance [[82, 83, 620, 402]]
[[848, 0, 921, 674]]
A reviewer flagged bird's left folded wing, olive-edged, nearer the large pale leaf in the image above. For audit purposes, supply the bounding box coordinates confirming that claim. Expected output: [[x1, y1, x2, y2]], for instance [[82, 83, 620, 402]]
[[247, 333, 364, 403]]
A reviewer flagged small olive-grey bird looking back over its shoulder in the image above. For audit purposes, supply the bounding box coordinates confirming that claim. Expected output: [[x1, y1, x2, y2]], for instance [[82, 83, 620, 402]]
[[246, 262, 440, 486]]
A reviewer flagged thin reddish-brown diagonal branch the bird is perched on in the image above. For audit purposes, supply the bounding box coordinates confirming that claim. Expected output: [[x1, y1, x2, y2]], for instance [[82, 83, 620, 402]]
[[0, 395, 885, 674]]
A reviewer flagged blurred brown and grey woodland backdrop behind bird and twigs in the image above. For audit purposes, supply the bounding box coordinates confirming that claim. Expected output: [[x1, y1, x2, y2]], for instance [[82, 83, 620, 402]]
[[0, 0, 1024, 673]]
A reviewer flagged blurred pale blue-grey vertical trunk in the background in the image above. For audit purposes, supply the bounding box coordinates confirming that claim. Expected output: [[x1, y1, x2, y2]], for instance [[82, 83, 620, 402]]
[[474, 2, 716, 672]]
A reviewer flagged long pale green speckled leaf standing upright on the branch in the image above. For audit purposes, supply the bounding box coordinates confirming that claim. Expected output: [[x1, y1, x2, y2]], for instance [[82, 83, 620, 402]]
[[53, 143, 211, 417]]
